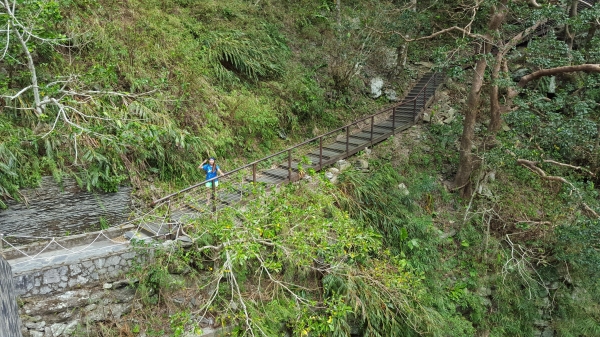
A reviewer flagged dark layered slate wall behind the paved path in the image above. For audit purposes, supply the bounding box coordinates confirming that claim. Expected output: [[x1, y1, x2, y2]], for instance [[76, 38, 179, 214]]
[[0, 177, 131, 237]]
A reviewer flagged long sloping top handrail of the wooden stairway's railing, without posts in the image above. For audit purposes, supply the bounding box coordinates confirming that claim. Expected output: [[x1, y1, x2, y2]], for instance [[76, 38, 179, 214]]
[[151, 73, 439, 206]]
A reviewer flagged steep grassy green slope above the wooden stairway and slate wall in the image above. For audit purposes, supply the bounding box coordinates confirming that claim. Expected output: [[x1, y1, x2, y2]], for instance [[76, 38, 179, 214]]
[[0, 0, 418, 203]]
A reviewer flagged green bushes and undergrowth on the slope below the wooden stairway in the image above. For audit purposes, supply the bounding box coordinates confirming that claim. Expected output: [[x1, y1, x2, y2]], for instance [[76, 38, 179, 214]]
[[102, 125, 600, 336]]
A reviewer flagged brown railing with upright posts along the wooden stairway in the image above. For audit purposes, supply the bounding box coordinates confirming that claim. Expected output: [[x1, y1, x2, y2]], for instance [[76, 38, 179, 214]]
[[152, 73, 441, 206]]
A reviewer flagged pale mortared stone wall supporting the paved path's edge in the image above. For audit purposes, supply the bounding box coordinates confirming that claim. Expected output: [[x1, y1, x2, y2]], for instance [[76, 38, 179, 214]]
[[13, 248, 135, 298]]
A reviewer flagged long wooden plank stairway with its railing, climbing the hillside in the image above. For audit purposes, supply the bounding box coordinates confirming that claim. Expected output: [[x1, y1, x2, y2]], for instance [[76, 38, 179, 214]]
[[153, 73, 442, 224]]
